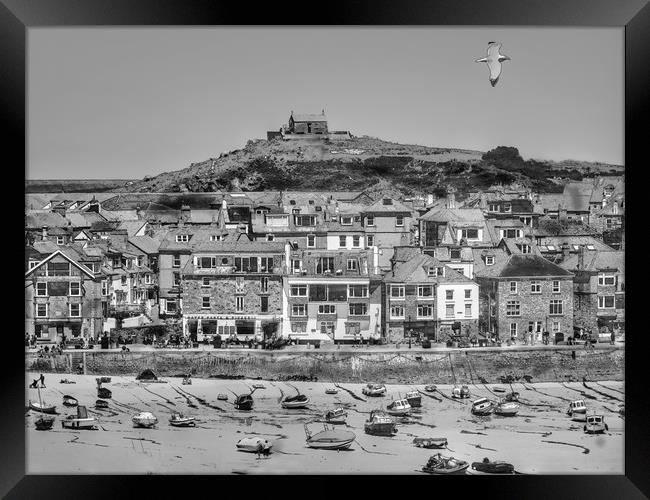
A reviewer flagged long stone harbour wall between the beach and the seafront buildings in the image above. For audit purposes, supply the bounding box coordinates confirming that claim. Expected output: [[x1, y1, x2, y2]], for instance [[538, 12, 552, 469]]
[[26, 346, 625, 384]]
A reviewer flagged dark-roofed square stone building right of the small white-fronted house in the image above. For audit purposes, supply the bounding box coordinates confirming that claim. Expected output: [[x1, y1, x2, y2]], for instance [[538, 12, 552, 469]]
[[474, 239, 573, 340]]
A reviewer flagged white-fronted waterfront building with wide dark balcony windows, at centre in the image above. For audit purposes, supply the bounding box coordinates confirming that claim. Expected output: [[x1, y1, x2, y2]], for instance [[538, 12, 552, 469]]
[[282, 248, 381, 343]]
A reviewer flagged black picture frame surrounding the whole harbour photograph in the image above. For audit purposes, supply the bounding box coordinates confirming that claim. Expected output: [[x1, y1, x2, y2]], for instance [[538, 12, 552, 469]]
[[0, 0, 650, 499]]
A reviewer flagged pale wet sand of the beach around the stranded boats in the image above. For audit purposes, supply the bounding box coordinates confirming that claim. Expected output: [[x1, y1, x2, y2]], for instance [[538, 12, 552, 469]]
[[25, 373, 625, 474]]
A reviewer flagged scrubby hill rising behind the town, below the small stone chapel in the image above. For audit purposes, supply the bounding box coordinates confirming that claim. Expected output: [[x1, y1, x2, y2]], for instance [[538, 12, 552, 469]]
[[113, 136, 623, 195]]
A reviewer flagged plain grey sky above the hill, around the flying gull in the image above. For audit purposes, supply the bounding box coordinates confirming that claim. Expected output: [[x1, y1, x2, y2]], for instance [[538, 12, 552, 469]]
[[26, 27, 624, 179]]
